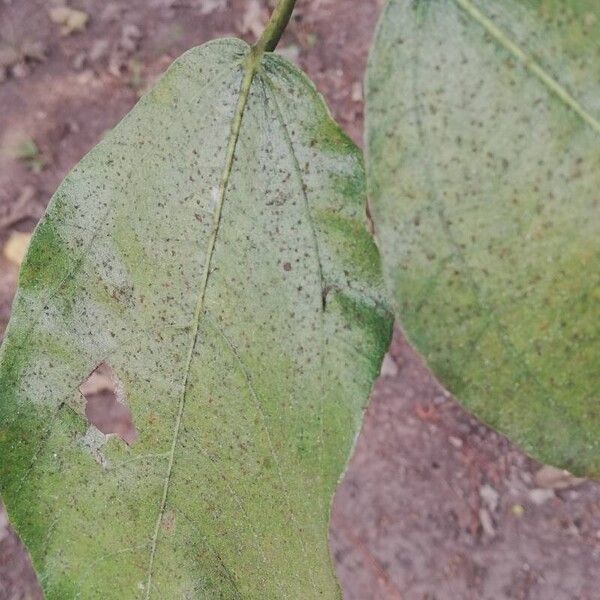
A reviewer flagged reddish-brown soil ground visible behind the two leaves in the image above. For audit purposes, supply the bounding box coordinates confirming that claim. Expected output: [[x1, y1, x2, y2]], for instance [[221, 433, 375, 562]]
[[0, 0, 600, 600]]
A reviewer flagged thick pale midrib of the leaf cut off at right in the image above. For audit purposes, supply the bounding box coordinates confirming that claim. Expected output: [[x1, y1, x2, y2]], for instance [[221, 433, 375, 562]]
[[454, 0, 600, 134]]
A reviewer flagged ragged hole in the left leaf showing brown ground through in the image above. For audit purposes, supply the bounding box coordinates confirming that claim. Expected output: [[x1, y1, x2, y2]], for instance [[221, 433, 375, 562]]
[[79, 362, 138, 446]]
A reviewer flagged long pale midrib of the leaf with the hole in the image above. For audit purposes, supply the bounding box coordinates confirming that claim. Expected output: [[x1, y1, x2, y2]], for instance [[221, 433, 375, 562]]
[[144, 49, 263, 600]]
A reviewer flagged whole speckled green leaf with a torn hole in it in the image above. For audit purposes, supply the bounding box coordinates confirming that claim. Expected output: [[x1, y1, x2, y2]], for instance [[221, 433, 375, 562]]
[[0, 40, 391, 600]]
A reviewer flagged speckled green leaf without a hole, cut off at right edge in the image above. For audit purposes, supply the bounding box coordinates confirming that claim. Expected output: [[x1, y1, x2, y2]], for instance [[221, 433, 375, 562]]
[[367, 0, 600, 476]]
